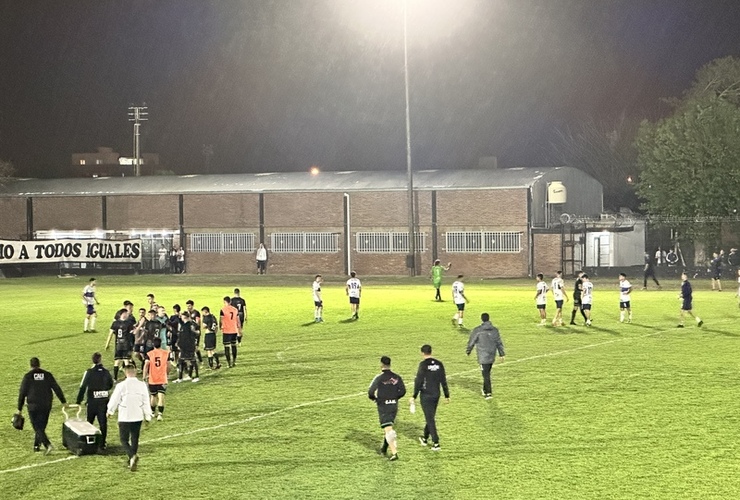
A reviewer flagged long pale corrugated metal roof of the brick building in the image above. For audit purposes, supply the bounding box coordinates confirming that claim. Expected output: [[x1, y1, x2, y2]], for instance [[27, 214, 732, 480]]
[[0, 167, 586, 197]]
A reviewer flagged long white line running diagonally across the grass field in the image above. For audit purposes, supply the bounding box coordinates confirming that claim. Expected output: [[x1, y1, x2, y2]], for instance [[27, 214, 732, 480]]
[[0, 328, 704, 474]]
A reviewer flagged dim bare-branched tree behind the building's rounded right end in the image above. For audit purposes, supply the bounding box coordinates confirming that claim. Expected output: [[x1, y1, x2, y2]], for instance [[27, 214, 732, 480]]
[[548, 116, 639, 210]]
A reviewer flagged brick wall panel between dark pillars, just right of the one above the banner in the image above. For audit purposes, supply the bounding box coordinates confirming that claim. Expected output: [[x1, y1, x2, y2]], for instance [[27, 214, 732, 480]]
[[107, 195, 180, 231]]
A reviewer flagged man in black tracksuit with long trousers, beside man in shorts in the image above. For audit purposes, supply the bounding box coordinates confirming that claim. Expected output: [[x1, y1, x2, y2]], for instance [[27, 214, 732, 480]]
[[411, 344, 450, 451]]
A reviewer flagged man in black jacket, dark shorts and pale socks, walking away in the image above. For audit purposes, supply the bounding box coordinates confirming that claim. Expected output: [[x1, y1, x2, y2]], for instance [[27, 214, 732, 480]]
[[367, 356, 406, 461]]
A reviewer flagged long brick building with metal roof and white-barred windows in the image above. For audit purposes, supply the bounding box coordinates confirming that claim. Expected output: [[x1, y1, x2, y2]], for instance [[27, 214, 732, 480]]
[[0, 167, 602, 277]]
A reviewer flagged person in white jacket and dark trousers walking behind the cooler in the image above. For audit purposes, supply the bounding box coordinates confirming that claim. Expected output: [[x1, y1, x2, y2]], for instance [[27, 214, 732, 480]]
[[108, 365, 152, 472]]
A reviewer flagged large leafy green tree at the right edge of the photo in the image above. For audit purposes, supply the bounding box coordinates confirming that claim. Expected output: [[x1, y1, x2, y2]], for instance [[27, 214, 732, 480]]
[[635, 58, 740, 242]]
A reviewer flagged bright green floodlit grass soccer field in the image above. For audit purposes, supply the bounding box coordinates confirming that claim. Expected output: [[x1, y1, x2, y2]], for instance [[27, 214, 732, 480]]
[[0, 276, 740, 499]]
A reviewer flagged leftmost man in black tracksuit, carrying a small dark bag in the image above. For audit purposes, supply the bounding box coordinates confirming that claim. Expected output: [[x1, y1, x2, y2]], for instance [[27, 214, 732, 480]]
[[18, 358, 67, 455]]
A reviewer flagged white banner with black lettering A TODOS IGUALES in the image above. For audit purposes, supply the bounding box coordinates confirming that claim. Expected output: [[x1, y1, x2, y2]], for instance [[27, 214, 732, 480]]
[[0, 240, 141, 265]]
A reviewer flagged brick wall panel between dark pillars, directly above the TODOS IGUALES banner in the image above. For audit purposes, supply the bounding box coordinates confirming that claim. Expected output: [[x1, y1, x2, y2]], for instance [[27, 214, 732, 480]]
[[33, 196, 103, 231]]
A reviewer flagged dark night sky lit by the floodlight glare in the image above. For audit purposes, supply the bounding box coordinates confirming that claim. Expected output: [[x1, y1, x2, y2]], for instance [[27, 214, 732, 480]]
[[0, 0, 740, 176]]
